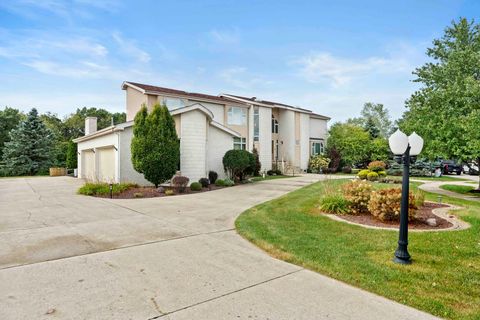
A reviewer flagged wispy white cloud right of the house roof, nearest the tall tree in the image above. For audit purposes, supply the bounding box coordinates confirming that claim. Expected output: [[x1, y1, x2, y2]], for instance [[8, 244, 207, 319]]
[[293, 52, 413, 86]]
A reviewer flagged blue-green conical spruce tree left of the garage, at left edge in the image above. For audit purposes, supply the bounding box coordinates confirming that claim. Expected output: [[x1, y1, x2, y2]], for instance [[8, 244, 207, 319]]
[[3, 108, 54, 175]]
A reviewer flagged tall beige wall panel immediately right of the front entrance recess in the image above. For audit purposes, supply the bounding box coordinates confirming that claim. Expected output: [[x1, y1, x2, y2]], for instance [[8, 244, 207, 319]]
[[278, 110, 295, 163]]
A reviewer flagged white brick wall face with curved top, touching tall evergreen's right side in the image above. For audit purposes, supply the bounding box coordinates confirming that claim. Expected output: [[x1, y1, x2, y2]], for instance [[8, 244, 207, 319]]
[[180, 110, 207, 182]]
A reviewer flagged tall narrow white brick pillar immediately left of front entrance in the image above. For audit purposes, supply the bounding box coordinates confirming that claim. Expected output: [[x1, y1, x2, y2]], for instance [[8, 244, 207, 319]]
[[252, 107, 272, 171]]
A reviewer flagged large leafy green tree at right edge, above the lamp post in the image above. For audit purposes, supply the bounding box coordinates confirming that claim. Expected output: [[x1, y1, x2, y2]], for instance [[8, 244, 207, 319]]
[[399, 18, 480, 188]]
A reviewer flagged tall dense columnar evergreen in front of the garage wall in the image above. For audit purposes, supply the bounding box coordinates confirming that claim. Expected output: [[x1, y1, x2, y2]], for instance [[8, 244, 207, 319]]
[[131, 104, 180, 187]]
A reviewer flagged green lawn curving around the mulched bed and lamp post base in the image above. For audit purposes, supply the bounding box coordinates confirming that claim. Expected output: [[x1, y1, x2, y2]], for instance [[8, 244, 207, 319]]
[[235, 180, 480, 320]]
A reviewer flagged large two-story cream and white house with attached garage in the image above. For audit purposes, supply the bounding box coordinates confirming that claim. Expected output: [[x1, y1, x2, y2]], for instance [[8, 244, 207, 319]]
[[74, 82, 330, 185]]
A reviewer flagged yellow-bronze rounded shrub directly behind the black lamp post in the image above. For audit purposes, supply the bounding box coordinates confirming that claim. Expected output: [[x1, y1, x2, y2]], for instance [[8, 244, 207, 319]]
[[368, 188, 417, 221]]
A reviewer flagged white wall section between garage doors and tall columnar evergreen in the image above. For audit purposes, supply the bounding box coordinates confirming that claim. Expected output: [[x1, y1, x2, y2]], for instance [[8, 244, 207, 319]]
[[118, 126, 152, 186]]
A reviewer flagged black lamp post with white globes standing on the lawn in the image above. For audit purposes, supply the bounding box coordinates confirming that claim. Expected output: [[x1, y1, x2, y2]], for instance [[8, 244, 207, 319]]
[[388, 130, 423, 264]]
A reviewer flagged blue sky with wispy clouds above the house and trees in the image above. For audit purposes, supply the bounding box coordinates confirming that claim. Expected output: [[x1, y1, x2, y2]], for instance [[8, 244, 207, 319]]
[[0, 0, 480, 121]]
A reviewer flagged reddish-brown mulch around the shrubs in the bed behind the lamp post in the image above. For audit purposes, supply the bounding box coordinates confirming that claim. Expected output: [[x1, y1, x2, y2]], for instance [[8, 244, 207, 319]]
[[336, 202, 453, 230]]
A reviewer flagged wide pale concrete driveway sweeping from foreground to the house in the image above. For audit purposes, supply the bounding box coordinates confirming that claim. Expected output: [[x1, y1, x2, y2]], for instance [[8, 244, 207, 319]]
[[0, 175, 434, 320]]
